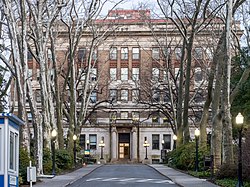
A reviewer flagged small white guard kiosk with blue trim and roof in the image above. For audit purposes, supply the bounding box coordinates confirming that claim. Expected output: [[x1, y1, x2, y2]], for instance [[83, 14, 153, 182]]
[[0, 113, 24, 187]]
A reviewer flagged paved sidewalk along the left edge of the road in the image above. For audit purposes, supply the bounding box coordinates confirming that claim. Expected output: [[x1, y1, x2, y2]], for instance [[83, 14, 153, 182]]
[[33, 165, 102, 187]]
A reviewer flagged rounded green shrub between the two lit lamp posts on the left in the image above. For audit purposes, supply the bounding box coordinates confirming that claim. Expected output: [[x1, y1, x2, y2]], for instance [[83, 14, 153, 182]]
[[56, 149, 73, 170]]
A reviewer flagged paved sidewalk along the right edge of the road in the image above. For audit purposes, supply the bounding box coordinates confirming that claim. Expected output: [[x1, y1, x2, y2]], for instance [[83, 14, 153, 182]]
[[149, 164, 218, 187]]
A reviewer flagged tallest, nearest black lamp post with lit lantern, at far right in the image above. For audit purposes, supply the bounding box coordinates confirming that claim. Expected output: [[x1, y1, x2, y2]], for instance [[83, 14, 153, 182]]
[[235, 113, 244, 187]]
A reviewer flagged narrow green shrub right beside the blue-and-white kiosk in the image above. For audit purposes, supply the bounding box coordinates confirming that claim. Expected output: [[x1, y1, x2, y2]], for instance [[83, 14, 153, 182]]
[[19, 147, 30, 184]]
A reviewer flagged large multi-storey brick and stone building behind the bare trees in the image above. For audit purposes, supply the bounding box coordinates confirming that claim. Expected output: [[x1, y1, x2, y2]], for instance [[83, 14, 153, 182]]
[[18, 10, 241, 163]]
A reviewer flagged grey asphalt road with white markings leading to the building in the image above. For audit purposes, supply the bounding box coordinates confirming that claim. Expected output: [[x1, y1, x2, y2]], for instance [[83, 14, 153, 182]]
[[69, 165, 178, 187]]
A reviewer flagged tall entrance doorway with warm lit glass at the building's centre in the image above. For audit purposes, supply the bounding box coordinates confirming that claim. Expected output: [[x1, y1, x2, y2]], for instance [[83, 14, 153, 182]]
[[118, 133, 130, 159]]
